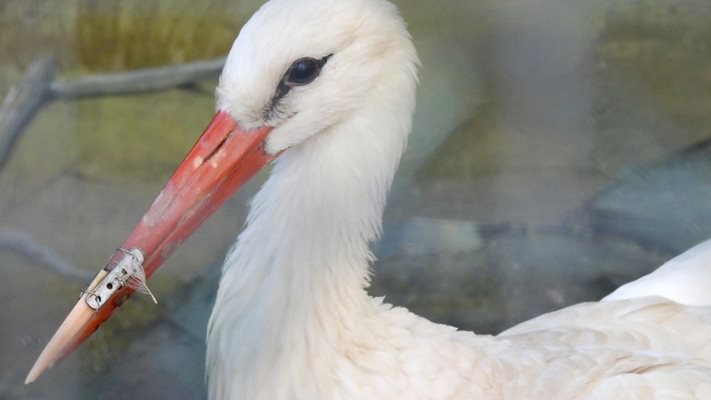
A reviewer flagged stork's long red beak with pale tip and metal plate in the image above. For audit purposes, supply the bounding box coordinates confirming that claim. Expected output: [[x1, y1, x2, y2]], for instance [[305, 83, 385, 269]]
[[25, 111, 275, 383]]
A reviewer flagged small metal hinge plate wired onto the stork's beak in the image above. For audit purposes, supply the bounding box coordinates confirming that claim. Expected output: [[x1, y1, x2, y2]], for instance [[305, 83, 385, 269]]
[[85, 248, 158, 310]]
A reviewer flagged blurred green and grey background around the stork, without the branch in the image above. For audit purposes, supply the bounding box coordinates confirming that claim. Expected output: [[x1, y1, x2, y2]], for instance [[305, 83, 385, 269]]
[[0, 0, 711, 399]]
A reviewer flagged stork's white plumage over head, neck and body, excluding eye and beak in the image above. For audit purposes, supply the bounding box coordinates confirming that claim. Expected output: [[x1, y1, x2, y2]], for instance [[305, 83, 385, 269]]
[[207, 0, 711, 400]]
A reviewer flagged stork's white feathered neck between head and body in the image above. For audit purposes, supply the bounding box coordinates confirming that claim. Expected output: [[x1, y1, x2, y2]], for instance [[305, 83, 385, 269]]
[[207, 66, 415, 399]]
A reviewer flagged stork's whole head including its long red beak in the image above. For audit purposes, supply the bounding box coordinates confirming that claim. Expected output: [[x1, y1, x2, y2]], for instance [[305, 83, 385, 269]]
[[26, 0, 417, 383]]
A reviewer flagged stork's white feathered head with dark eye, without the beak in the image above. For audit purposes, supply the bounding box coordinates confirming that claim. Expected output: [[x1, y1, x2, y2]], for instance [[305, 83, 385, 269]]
[[217, 0, 417, 154]]
